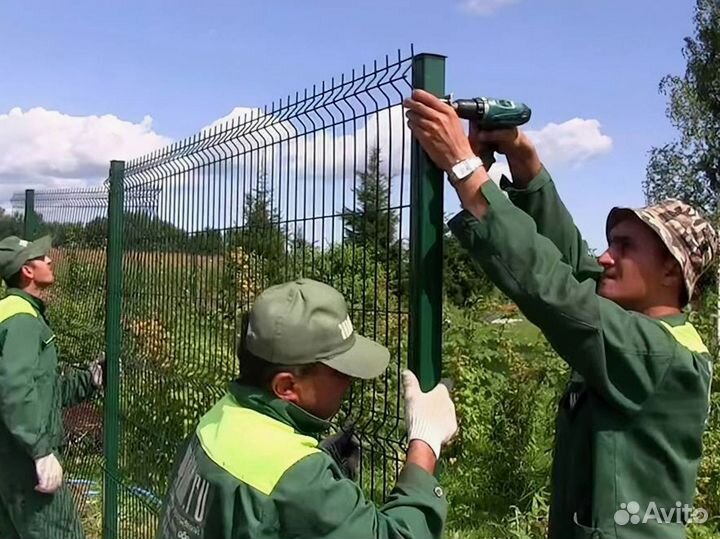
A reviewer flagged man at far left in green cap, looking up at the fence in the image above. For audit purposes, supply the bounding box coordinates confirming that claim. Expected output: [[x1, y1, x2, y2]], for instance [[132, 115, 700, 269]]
[[0, 236, 104, 539]]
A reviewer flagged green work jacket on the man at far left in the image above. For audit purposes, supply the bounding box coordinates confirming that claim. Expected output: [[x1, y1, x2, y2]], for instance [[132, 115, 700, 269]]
[[0, 289, 95, 460]]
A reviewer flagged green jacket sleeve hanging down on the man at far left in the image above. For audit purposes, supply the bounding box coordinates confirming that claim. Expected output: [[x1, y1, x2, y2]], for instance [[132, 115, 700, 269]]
[[0, 314, 51, 459]]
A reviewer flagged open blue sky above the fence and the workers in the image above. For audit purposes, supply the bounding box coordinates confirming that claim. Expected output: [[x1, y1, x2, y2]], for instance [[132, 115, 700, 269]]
[[0, 0, 694, 248]]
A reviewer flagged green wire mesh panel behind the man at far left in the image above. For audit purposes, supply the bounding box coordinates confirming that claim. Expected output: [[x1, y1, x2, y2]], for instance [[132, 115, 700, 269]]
[[7, 188, 108, 539]]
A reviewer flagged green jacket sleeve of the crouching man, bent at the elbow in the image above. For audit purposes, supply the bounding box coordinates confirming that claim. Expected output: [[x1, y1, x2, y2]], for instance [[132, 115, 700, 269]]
[[272, 454, 447, 539]]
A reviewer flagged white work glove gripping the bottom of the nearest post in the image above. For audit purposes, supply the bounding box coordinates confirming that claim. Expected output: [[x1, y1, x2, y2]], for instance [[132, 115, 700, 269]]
[[403, 370, 458, 458]]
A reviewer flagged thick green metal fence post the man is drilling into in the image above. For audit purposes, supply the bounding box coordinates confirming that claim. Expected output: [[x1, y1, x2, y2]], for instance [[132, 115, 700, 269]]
[[408, 54, 445, 390]]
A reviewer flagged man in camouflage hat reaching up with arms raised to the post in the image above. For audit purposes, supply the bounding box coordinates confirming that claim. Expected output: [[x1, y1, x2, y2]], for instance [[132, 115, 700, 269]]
[[406, 91, 717, 539]]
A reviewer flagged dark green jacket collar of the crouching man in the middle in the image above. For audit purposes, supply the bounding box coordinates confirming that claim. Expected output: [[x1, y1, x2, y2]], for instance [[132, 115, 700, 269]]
[[230, 381, 330, 436]]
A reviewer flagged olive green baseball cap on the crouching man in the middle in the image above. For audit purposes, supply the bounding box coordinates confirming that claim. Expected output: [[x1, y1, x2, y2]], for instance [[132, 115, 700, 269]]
[[245, 279, 390, 380]]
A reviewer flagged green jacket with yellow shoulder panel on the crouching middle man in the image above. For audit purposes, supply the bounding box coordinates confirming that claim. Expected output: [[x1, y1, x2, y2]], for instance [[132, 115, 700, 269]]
[[157, 383, 447, 539]]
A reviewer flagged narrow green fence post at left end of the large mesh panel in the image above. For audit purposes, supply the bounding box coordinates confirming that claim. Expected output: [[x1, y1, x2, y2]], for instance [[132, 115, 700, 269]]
[[103, 161, 125, 539]]
